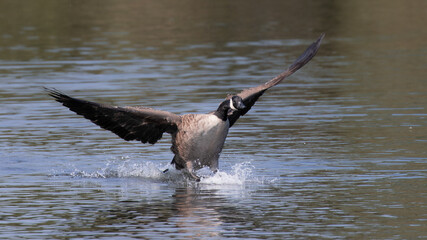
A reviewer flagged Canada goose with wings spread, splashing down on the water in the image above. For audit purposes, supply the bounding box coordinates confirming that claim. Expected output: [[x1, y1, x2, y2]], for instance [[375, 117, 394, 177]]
[[45, 34, 324, 181]]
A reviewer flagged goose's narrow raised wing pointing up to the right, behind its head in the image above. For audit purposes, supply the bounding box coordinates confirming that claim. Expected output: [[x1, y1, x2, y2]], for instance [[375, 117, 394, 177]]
[[228, 34, 325, 127]]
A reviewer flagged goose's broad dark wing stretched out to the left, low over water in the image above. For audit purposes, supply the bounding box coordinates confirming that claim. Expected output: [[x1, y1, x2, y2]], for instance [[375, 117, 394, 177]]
[[45, 88, 181, 144]]
